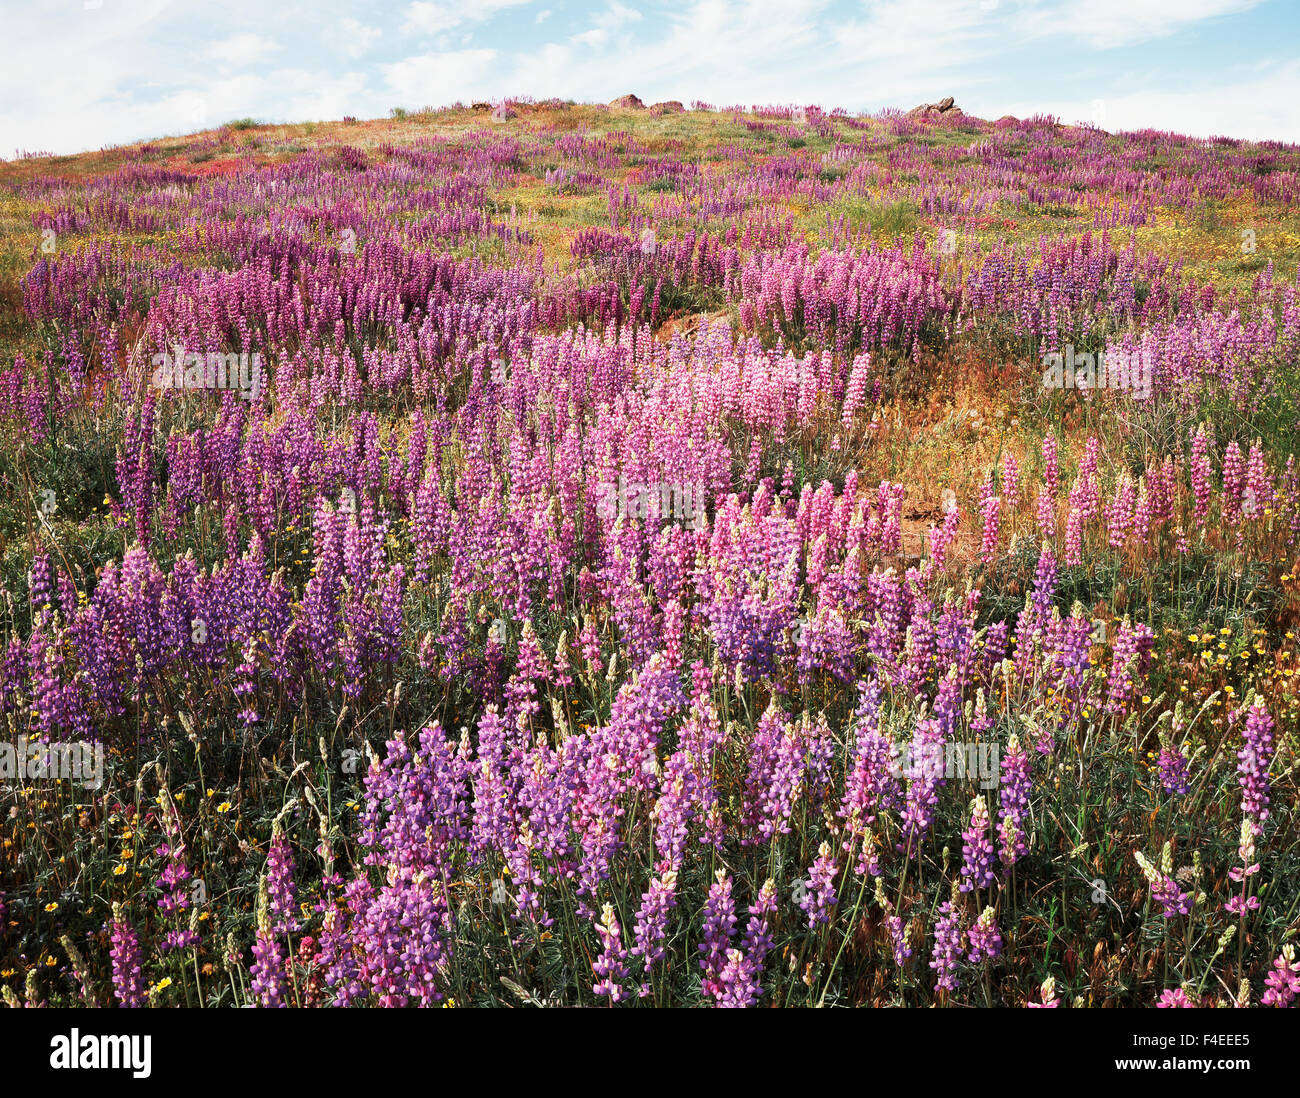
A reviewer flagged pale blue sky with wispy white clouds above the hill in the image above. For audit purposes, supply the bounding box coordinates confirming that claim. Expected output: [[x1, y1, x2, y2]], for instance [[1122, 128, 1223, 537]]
[[0, 0, 1300, 156]]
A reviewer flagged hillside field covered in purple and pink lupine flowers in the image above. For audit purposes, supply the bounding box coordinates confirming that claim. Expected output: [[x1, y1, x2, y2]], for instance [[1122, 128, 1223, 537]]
[[0, 101, 1300, 1007]]
